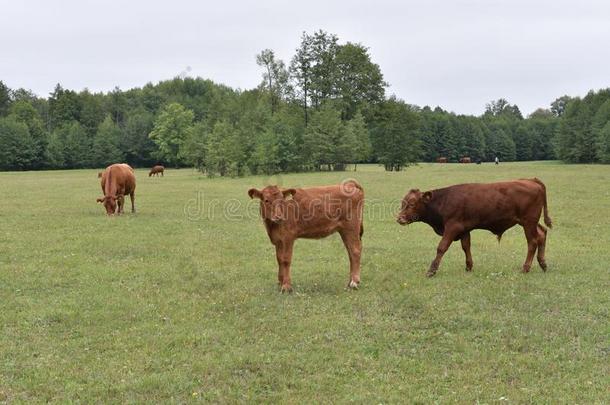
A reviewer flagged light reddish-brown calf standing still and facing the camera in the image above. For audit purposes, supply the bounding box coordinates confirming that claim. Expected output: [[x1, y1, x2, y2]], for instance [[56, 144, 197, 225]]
[[248, 180, 364, 292]]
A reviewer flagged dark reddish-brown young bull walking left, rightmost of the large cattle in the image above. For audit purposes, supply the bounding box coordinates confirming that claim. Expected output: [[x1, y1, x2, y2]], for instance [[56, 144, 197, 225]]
[[397, 178, 552, 277]]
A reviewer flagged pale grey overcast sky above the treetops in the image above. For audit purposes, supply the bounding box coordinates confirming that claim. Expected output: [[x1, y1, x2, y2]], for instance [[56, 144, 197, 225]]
[[0, 0, 610, 115]]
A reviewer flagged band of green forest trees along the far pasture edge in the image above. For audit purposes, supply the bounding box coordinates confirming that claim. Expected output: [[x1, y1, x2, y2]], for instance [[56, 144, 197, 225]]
[[0, 31, 610, 172]]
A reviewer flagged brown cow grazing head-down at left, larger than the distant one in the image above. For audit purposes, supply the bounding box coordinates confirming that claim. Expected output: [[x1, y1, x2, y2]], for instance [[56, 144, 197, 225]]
[[97, 163, 136, 215]]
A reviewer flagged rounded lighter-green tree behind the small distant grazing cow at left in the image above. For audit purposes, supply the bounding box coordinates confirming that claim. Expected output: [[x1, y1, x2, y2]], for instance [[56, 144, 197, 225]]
[[149, 103, 194, 165]]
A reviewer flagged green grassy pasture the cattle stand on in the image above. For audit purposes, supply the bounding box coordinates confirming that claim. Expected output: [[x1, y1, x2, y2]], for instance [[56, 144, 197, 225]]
[[0, 162, 610, 403]]
